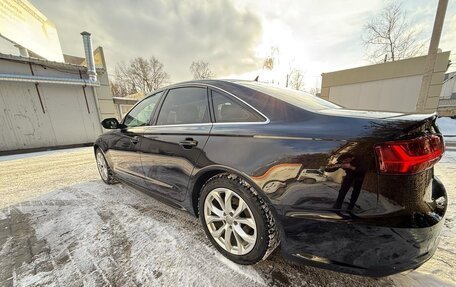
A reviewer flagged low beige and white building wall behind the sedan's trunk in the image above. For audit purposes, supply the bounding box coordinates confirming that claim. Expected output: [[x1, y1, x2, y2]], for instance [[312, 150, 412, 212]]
[[320, 52, 450, 113]]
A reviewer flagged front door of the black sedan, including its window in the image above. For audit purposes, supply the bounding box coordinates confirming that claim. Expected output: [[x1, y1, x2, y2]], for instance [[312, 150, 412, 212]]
[[109, 92, 163, 187]]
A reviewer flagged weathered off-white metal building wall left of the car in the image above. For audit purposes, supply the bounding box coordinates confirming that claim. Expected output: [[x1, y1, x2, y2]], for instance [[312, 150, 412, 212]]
[[0, 60, 102, 152]]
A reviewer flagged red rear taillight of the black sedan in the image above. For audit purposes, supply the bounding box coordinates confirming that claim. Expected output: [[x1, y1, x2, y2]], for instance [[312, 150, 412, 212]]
[[375, 135, 445, 174]]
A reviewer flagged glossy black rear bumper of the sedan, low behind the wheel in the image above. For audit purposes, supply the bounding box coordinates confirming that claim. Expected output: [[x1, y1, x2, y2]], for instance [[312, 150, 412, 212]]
[[281, 179, 446, 277]]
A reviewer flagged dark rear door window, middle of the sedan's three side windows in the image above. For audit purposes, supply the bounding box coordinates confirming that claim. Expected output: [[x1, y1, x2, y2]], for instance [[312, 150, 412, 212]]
[[157, 87, 210, 125]]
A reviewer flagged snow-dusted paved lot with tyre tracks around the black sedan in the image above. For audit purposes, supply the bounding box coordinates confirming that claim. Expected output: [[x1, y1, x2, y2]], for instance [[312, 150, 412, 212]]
[[0, 148, 456, 286]]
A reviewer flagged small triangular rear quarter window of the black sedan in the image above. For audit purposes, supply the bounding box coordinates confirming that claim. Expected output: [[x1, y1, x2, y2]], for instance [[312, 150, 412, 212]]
[[212, 91, 264, 123]]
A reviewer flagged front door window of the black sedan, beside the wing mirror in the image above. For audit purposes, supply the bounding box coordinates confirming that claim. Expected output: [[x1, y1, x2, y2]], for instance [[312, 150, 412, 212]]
[[124, 92, 163, 128]]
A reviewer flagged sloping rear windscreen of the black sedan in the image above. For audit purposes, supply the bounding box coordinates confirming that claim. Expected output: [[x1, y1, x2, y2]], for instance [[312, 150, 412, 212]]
[[240, 82, 342, 111]]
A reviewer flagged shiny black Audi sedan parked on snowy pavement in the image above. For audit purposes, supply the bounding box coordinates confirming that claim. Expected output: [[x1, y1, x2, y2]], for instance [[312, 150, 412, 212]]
[[94, 80, 447, 276]]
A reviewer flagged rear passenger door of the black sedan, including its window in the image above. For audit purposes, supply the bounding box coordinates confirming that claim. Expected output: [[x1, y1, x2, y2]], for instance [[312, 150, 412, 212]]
[[141, 86, 212, 201]]
